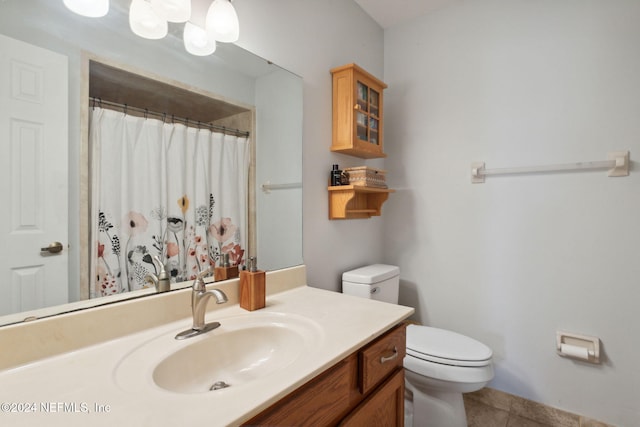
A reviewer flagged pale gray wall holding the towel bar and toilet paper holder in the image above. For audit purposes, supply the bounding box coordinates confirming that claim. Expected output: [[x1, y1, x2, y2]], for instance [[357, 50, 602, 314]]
[[383, 0, 640, 426]]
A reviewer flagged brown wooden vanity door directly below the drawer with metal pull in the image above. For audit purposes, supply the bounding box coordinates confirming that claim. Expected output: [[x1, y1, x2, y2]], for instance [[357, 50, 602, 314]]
[[340, 368, 404, 427]]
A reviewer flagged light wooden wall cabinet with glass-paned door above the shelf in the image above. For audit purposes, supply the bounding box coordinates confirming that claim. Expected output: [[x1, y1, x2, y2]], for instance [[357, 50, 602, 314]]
[[331, 64, 387, 159]]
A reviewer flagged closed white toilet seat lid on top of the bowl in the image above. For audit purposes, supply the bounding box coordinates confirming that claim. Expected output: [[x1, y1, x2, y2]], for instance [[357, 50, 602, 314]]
[[407, 325, 493, 366]]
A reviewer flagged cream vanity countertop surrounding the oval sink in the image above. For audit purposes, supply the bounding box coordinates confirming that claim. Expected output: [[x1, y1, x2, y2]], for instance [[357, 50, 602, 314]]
[[0, 286, 413, 427]]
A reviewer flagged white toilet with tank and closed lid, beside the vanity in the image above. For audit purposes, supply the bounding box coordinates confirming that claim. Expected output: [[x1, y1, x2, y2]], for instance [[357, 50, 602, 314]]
[[342, 264, 493, 427]]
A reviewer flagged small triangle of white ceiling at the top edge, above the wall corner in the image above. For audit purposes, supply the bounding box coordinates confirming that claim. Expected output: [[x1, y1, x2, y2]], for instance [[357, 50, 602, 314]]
[[355, 0, 459, 28]]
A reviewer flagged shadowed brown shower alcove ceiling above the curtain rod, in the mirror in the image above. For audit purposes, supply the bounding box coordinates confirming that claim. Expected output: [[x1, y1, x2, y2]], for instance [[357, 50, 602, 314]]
[[89, 61, 248, 125]]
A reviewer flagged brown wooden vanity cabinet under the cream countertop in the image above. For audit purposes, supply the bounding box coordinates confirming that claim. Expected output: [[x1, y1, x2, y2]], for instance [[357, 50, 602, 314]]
[[244, 324, 406, 427]]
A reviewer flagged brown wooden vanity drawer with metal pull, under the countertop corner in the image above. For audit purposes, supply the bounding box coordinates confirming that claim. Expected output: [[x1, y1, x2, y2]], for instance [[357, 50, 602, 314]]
[[358, 324, 407, 394]]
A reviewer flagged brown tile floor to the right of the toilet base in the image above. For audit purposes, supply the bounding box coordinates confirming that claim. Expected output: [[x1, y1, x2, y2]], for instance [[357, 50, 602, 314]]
[[464, 388, 612, 427]]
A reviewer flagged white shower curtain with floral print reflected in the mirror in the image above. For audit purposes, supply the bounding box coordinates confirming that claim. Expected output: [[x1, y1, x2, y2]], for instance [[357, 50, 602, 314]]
[[89, 107, 249, 298]]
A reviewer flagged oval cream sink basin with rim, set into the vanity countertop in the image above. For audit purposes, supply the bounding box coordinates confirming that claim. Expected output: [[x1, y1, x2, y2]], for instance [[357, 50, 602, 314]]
[[116, 313, 322, 394]]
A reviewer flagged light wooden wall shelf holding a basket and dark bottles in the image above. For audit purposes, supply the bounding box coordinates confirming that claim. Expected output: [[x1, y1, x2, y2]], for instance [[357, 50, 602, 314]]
[[329, 185, 395, 219]]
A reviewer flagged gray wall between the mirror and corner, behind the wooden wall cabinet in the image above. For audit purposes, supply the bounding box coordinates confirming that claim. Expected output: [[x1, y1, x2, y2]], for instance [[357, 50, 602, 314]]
[[234, 0, 384, 291]]
